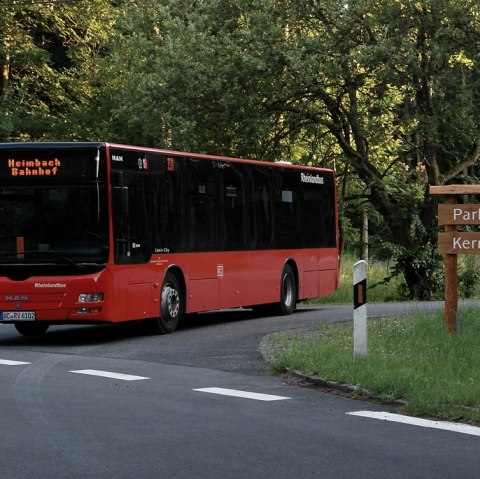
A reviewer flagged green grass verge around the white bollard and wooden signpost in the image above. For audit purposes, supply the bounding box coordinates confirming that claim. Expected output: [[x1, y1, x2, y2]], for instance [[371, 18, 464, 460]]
[[274, 309, 480, 423]]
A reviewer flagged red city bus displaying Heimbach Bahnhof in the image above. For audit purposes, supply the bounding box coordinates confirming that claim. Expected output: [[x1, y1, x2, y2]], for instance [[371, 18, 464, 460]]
[[0, 142, 339, 335]]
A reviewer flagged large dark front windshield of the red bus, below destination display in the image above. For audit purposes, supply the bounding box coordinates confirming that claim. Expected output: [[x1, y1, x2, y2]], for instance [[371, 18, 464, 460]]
[[0, 183, 108, 277]]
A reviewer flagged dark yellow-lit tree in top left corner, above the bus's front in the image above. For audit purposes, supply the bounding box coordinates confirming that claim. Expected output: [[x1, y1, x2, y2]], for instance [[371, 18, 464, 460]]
[[0, 0, 115, 140]]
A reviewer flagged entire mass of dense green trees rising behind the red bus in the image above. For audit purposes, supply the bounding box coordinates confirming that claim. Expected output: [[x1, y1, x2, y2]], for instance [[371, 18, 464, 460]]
[[0, 0, 480, 299]]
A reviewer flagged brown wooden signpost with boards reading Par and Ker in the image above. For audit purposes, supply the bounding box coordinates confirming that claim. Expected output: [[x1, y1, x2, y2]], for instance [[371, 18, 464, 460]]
[[430, 185, 480, 332]]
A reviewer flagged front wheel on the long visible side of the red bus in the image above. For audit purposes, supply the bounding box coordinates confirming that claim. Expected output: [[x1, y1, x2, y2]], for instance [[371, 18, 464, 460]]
[[153, 273, 185, 334]]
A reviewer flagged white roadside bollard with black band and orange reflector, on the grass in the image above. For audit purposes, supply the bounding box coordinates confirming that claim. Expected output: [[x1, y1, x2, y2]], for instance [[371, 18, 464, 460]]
[[353, 260, 368, 357]]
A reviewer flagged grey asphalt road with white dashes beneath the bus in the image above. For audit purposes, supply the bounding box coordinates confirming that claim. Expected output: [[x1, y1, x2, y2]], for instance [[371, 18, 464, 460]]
[[0, 303, 480, 479]]
